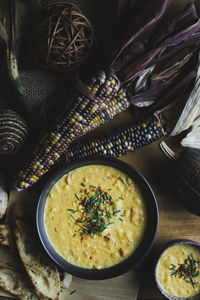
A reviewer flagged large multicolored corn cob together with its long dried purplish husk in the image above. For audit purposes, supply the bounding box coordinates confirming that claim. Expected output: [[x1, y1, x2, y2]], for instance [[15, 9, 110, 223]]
[[17, 0, 200, 191]]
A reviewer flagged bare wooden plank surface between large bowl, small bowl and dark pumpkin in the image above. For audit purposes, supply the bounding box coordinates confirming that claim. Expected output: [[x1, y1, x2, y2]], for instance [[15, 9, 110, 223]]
[[123, 139, 200, 300]]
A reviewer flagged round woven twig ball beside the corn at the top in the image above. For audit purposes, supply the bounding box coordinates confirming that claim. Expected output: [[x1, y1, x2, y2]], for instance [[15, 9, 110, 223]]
[[32, 2, 94, 71]]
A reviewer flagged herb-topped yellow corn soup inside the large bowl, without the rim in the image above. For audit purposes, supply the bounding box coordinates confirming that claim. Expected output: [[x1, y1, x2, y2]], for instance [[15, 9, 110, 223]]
[[44, 165, 146, 269]]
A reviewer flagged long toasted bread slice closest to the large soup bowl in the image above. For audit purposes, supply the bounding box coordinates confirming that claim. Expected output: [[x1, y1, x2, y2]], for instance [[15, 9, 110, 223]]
[[15, 219, 60, 299]]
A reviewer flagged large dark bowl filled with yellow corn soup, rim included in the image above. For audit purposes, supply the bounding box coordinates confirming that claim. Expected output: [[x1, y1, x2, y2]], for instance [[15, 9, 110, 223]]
[[36, 158, 158, 279]]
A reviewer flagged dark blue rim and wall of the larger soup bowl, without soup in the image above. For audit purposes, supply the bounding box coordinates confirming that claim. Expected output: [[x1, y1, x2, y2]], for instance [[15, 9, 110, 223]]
[[36, 157, 159, 279]]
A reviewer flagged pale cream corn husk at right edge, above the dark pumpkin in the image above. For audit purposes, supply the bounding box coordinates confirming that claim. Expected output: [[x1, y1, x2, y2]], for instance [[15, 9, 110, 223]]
[[170, 55, 200, 135]]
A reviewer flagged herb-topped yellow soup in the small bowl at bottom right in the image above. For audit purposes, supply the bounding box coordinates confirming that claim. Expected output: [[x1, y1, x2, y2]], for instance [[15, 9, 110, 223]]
[[156, 244, 200, 298]]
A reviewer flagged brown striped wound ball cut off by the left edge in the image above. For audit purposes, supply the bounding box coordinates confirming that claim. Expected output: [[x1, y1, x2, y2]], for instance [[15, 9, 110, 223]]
[[0, 109, 28, 155]]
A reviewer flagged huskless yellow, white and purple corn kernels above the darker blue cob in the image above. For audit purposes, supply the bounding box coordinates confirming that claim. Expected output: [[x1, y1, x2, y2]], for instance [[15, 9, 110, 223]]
[[16, 71, 129, 191]]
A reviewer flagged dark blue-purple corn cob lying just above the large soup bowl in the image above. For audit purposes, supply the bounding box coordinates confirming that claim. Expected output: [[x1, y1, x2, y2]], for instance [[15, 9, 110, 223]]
[[65, 117, 164, 162]]
